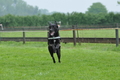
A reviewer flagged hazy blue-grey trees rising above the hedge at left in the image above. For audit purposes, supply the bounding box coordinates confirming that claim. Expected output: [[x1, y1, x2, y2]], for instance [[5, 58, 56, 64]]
[[0, 0, 50, 16]]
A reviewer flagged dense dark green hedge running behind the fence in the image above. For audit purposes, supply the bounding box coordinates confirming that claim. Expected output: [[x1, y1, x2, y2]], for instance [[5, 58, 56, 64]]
[[0, 12, 120, 27]]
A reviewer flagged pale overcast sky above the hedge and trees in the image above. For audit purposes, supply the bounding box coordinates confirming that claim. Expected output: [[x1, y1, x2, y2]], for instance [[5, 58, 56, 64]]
[[23, 0, 120, 13]]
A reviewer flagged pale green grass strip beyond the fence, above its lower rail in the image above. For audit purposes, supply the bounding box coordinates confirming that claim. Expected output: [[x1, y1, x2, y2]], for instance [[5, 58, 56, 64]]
[[0, 29, 120, 38]]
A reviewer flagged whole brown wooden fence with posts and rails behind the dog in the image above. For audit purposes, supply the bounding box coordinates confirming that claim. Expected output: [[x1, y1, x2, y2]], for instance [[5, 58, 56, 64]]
[[0, 24, 120, 46]]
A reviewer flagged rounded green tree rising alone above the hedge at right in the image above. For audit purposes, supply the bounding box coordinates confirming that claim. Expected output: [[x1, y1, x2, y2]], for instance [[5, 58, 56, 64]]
[[86, 2, 107, 14]]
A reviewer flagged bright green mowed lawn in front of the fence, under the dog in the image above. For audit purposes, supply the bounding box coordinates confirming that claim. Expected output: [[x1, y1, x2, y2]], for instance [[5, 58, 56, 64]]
[[0, 42, 120, 80]]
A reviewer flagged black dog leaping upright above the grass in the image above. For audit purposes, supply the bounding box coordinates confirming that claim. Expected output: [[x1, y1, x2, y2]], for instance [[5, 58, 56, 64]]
[[48, 22, 61, 63]]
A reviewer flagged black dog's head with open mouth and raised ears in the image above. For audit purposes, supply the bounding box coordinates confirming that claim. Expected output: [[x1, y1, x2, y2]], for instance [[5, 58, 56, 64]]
[[48, 22, 59, 37]]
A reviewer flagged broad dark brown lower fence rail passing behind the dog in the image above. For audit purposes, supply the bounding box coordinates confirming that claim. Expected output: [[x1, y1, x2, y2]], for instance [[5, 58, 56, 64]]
[[0, 37, 116, 43]]
